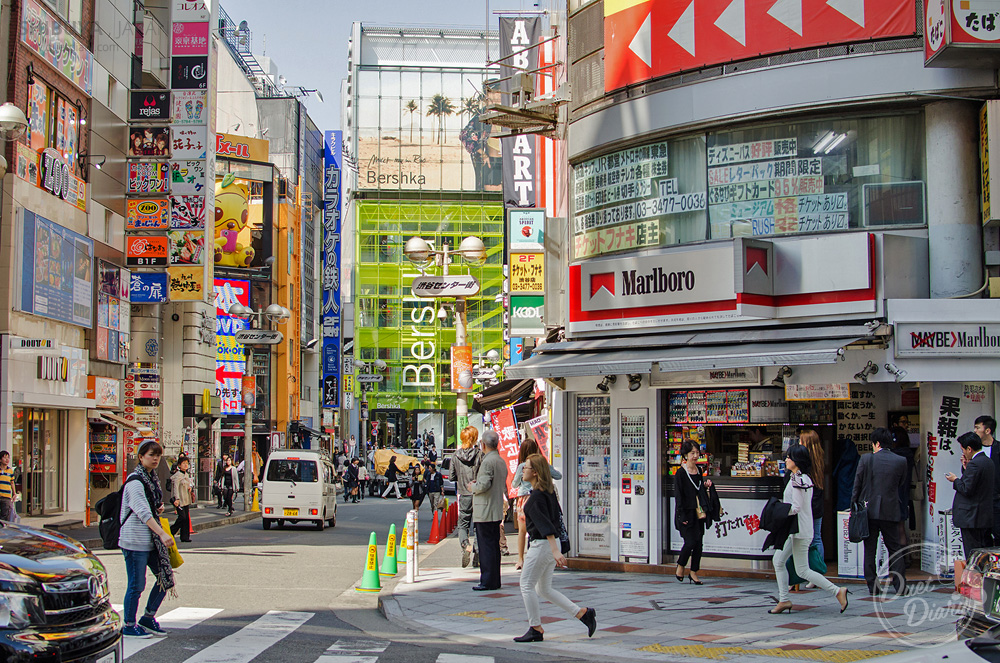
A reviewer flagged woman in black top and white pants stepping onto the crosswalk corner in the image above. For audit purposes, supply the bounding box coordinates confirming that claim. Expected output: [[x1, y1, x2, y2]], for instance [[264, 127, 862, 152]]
[[514, 454, 597, 642]]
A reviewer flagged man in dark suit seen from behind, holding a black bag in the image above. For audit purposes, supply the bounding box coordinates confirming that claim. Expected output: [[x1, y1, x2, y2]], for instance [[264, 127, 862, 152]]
[[851, 428, 909, 596]]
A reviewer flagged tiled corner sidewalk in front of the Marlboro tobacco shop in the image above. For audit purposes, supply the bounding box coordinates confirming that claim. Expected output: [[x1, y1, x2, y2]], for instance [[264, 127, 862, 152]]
[[379, 537, 955, 663]]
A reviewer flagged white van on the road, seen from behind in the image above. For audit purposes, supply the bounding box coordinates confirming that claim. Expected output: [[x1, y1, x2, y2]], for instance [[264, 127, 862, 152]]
[[260, 449, 337, 531]]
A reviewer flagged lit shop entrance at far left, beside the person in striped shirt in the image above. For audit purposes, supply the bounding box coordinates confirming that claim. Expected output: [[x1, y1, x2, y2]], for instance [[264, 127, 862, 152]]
[[11, 407, 67, 516]]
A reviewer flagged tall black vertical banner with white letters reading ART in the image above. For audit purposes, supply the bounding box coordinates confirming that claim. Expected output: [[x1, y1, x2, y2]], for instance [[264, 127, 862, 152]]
[[500, 16, 542, 207]]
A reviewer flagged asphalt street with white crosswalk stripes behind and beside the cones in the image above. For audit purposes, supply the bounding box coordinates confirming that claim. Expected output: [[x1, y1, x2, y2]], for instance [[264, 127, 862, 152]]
[[98, 499, 570, 663]]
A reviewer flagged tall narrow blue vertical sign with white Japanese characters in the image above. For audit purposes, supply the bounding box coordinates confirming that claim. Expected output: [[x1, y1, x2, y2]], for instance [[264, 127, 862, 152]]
[[321, 131, 344, 408]]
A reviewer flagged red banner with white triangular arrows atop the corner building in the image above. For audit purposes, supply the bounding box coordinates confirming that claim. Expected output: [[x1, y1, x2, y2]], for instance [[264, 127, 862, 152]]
[[604, 0, 917, 91]]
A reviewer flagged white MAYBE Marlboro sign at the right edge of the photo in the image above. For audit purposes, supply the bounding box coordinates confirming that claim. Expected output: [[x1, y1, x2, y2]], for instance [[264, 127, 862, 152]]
[[895, 322, 1000, 357]]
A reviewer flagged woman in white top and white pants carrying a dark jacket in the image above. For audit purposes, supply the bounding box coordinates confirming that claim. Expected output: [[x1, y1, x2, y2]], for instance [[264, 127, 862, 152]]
[[768, 444, 850, 615]]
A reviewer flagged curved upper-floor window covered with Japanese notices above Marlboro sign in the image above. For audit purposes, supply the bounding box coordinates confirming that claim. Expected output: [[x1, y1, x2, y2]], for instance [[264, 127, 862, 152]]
[[573, 112, 926, 260]]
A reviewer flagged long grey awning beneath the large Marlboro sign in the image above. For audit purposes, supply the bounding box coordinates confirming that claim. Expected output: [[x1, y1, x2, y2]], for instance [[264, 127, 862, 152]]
[[506, 337, 861, 379]]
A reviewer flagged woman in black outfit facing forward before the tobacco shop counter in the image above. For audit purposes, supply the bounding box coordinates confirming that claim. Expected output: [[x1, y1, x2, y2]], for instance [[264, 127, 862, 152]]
[[674, 440, 712, 585]]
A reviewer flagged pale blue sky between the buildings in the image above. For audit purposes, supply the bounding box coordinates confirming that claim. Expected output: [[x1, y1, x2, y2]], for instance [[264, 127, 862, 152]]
[[221, 0, 547, 131]]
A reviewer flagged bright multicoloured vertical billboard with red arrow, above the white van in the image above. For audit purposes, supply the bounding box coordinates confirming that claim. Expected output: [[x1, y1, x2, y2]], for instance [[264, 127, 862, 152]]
[[214, 278, 250, 416]]
